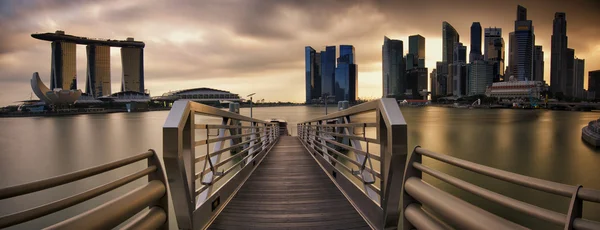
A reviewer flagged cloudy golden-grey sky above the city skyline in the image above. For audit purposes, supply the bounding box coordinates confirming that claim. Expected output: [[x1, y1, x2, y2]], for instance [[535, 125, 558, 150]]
[[0, 0, 600, 106]]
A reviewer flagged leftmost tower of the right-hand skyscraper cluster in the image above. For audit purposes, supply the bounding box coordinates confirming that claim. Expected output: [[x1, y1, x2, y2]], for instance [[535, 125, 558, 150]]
[[382, 37, 406, 97]]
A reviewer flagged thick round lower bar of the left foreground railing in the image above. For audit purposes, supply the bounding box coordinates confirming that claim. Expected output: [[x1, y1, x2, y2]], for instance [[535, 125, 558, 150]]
[[49, 180, 167, 229]]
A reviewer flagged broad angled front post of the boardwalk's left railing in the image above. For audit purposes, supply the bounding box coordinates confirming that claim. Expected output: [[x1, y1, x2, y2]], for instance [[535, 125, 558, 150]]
[[163, 101, 196, 229]]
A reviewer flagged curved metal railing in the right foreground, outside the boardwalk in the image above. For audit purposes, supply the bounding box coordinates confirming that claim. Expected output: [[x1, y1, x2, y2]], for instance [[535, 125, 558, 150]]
[[402, 146, 600, 229]]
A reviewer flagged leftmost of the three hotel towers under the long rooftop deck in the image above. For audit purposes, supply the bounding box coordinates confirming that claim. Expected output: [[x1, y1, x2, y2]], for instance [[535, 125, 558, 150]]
[[50, 41, 77, 90]]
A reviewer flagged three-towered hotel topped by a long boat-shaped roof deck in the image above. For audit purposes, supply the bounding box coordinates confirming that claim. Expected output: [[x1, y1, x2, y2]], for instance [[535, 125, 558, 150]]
[[31, 30, 145, 97]]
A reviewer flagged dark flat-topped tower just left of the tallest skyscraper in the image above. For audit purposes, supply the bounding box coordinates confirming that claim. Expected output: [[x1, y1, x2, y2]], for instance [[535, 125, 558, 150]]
[[483, 27, 506, 82]]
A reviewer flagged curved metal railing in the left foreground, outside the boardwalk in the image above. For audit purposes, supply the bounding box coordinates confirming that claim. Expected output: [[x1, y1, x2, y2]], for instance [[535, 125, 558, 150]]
[[0, 150, 169, 229]]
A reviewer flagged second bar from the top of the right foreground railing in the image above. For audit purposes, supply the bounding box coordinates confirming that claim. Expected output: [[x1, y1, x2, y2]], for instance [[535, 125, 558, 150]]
[[412, 162, 567, 225]]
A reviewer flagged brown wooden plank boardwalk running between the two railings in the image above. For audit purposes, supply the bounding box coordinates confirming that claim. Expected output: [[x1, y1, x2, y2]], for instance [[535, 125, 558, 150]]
[[209, 136, 370, 229]]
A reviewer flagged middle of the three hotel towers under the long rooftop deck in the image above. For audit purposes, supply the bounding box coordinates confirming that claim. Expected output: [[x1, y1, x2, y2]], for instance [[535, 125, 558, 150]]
[[85, 45, 111, 97]]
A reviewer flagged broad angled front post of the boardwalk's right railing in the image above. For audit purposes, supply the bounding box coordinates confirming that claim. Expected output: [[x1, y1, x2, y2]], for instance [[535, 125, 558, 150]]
[[375, 98, 408, 228]]
